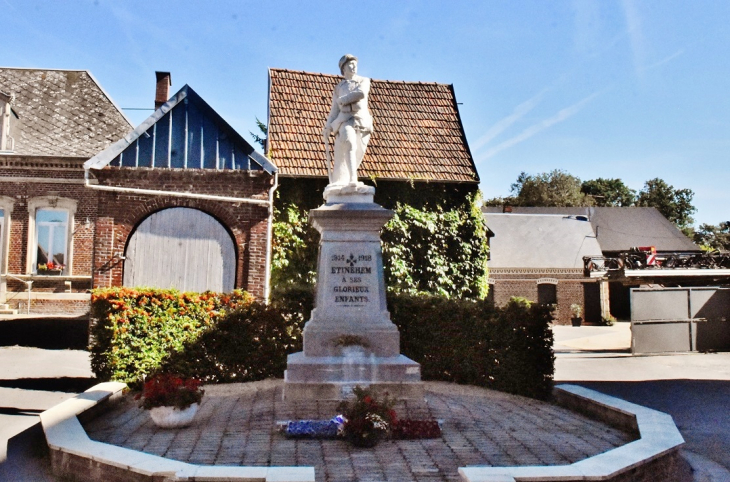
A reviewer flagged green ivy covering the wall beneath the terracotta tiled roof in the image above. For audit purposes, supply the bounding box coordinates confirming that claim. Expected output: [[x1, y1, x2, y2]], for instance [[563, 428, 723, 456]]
[[271, 179, 488, 298]]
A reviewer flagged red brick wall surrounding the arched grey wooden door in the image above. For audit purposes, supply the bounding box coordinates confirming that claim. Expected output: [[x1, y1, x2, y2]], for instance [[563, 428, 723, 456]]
[[94, 168, 273, 298]]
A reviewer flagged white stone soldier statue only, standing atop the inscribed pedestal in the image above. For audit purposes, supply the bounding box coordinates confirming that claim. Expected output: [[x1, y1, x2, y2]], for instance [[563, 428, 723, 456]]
[[322, 54, 373, 190]]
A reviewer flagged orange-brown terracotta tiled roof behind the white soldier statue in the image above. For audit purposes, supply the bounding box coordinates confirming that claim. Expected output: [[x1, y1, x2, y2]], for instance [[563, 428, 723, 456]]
[[269, 69, 479, 182]]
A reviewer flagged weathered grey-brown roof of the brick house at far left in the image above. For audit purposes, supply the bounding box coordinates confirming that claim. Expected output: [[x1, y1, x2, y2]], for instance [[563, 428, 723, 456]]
[[0, 67, 133, 157]]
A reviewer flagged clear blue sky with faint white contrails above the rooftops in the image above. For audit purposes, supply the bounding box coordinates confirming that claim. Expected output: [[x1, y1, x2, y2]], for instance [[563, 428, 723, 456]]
[[0, 0, 730, 224]]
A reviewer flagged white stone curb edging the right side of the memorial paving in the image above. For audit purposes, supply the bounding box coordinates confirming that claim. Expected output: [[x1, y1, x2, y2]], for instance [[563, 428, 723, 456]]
[[459, 385, 684, 482]]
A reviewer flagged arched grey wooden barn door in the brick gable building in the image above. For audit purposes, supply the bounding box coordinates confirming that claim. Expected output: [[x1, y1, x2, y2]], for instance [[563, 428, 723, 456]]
[[124, 208, 236, 292]]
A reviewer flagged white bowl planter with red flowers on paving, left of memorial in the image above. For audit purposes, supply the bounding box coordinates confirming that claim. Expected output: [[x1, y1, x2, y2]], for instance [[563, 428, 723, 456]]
[[135, 373, 205, 428]]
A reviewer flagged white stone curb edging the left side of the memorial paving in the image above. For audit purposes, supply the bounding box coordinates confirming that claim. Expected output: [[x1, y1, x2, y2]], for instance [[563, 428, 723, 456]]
[[41, 382, 314, 482]]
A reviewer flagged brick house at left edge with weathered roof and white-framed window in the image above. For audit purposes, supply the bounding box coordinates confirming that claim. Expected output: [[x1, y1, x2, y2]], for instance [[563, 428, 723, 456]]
[[0, 68, 132, 313]]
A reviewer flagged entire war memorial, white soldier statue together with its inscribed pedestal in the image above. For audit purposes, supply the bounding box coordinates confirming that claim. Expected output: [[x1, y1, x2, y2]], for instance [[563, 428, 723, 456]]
[[284, 54, 423, 400]]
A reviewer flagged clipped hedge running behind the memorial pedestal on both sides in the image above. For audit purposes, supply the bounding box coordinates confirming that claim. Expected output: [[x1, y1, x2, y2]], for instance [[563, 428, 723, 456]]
[[92, 287, 554, 399]]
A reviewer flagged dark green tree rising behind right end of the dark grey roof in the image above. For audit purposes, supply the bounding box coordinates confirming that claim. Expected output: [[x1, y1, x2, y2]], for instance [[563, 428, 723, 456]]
[[636, 178, 697, 229]]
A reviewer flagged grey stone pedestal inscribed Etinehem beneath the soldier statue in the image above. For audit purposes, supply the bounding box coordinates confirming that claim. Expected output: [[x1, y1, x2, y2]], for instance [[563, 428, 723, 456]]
[[284, 187, 423, 400]]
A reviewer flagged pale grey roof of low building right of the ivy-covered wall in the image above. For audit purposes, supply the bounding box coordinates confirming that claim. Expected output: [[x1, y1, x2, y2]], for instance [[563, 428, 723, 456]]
[[485, 213, 602, 269]]
